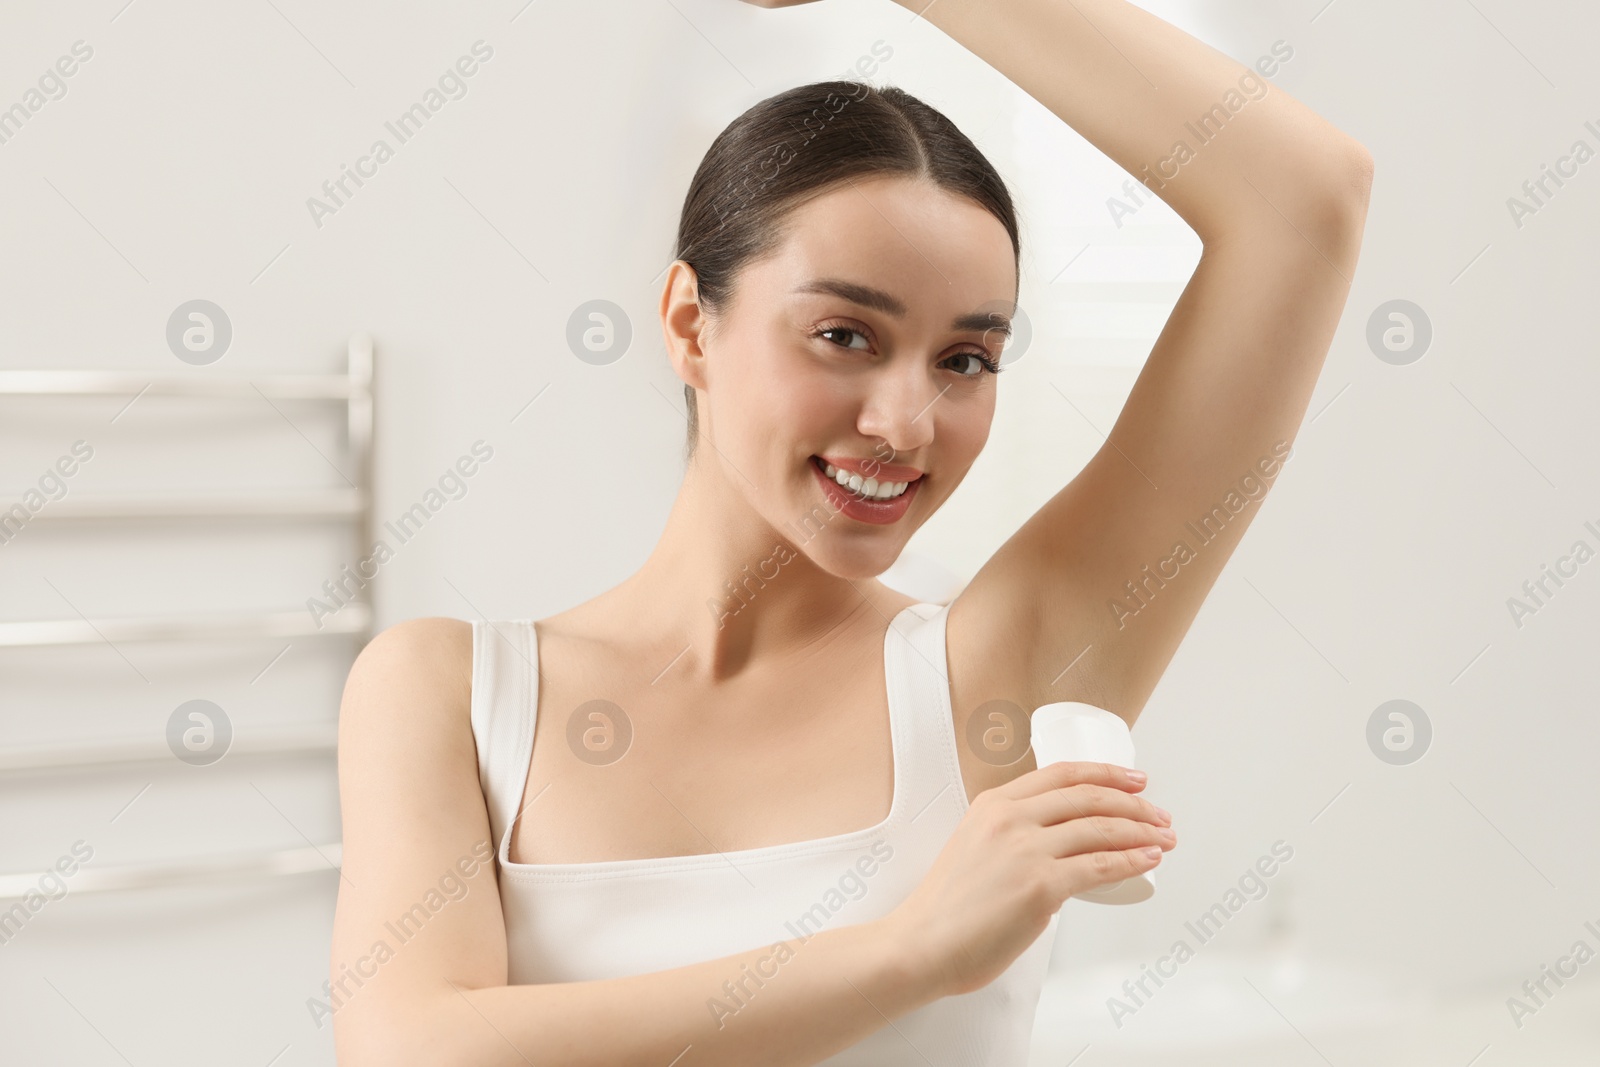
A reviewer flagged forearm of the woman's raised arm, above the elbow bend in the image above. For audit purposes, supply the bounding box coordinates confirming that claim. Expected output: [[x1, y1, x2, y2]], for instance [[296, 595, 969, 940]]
[[894, 0, 1365, 240]]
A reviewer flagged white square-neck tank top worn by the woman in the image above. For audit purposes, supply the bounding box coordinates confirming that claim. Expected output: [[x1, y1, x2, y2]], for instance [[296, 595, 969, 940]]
[[472, 603, 1058, 1067]]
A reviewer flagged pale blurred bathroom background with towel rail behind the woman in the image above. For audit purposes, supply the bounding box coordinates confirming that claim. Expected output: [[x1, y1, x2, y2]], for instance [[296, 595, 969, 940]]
[[0, 0, 1600, 1067]]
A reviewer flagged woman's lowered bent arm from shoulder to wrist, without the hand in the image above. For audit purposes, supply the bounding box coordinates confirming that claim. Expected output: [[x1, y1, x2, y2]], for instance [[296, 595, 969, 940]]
[[329, 619, 944, 1067]]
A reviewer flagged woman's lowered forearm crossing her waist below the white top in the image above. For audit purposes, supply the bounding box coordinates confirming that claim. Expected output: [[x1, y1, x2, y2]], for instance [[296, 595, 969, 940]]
[[380, 921, 942, 1067]]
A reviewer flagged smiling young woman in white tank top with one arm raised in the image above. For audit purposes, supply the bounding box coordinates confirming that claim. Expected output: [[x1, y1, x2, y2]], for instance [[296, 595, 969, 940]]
[[328, 0, 1373, 1067]]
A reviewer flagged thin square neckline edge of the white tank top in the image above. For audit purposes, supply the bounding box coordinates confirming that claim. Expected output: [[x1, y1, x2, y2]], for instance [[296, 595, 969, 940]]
[[494, 601, 950, 881]]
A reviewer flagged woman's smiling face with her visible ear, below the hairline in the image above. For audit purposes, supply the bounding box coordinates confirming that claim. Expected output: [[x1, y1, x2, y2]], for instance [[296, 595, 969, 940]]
[[662, 174, 1018, 577]]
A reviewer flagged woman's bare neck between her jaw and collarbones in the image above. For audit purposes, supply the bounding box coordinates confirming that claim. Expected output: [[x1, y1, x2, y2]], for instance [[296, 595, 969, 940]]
[[614, 445, 907, 683]]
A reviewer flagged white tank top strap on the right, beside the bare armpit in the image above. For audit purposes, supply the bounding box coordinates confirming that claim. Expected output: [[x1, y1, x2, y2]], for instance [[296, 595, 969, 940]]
[[883, 603, 968, 832]]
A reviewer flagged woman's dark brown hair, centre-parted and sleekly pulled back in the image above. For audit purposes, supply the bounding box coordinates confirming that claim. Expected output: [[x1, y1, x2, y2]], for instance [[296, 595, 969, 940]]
[[675, 80, 1021, 458]]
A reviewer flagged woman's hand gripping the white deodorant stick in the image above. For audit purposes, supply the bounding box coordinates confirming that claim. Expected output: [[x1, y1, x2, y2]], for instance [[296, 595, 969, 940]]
[[882, 763, 1176, 997]]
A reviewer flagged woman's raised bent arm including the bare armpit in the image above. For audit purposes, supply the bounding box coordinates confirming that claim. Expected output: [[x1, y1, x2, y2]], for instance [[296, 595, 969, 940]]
[[921, 0, 1373, 723]]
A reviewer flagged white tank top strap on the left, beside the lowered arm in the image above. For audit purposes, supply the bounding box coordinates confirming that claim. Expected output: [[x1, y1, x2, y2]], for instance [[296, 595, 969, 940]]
[[472, 619, 538, 859]]
